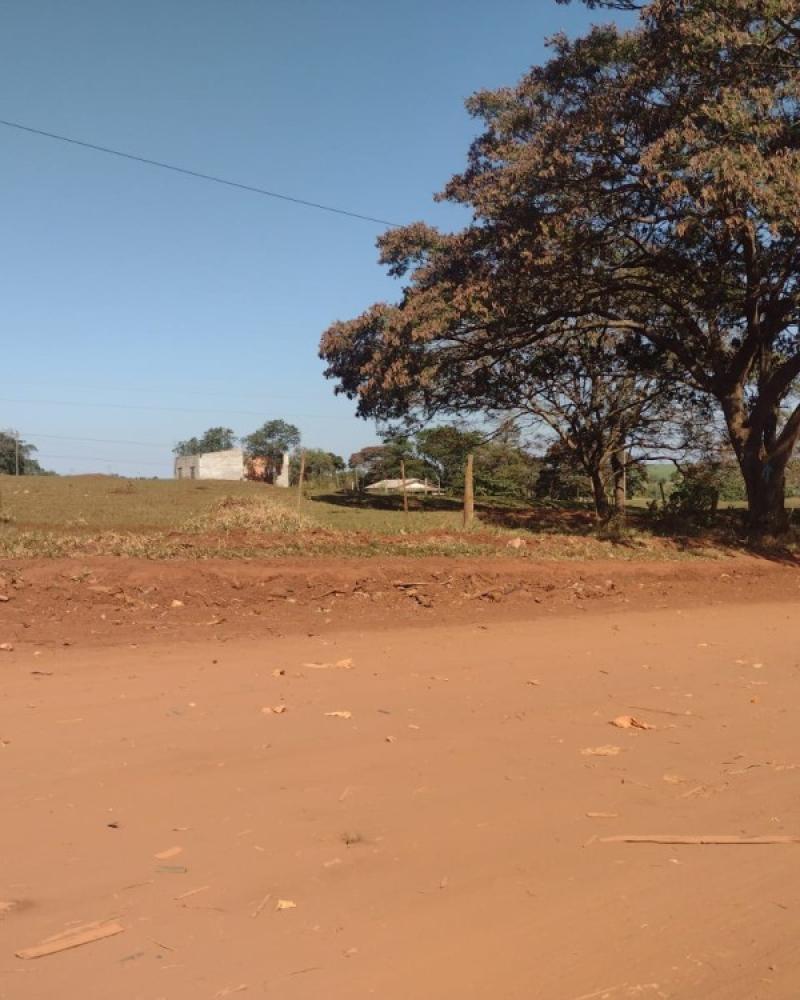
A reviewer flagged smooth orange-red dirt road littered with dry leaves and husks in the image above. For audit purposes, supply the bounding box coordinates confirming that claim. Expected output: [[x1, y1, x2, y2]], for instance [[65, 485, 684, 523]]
[[0, 571, 800, 1000]]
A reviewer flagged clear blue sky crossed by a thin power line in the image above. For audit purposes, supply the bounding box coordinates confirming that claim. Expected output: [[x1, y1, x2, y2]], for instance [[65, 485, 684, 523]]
[[0, 0, 632, 475]]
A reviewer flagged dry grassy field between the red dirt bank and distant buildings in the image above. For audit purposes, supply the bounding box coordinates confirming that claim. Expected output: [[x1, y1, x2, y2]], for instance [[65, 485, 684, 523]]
[[0, 476, 796, 559]]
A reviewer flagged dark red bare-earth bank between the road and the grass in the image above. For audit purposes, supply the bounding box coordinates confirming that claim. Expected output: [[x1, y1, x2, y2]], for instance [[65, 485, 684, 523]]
[[0, 557, 800, 644]]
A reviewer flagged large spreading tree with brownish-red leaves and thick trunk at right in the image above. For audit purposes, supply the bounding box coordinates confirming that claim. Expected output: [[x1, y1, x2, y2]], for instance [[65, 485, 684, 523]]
[[321, 0, 800, 529]]
